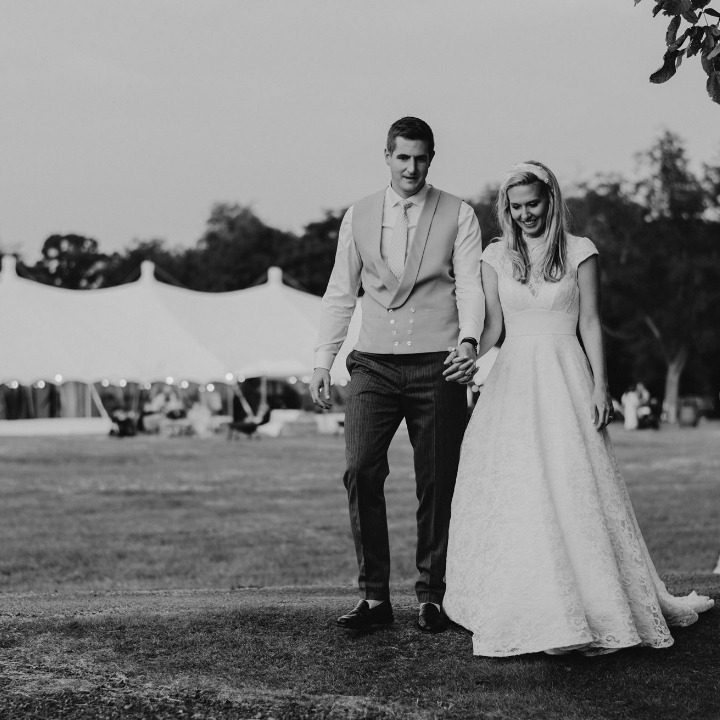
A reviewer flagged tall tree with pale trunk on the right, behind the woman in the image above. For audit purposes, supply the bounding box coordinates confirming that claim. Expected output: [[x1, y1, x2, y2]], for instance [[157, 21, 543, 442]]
[[576, 133, 720, 422]]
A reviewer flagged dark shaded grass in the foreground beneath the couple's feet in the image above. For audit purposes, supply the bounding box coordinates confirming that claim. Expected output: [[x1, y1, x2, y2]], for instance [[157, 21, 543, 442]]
[[0, 576, 720, 720]]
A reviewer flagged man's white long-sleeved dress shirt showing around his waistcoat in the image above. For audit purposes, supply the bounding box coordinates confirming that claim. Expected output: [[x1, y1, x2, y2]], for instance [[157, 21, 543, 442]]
[[315, 183, 485, 370]]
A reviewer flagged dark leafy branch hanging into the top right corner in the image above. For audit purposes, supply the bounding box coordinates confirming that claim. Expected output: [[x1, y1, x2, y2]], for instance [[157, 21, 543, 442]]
[[635, 0, 720, 103]]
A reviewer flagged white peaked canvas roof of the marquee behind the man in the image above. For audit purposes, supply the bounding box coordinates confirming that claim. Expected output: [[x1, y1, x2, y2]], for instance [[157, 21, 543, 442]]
[[0, 255, 360, 434]]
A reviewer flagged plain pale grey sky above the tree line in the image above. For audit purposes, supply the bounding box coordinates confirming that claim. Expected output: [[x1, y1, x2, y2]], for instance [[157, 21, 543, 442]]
[[0, 0, 720, 262]]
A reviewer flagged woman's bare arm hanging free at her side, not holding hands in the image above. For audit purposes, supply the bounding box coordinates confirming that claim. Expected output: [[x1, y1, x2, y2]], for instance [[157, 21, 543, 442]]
[[578, 255, 612, 430]]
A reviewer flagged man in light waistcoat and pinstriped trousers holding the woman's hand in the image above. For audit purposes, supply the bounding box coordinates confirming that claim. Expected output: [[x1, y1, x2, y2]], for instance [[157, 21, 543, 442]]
[[310, 117, 484, 632]]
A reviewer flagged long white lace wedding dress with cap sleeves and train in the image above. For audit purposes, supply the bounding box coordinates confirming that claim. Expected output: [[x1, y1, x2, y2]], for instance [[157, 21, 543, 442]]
[[443, 236, 713, 656]]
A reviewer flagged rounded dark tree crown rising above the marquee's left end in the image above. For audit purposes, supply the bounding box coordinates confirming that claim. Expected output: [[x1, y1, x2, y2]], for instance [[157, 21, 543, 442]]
[[28, 235, 108, 290]]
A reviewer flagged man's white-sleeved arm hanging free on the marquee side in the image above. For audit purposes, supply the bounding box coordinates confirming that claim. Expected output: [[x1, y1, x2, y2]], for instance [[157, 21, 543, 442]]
[[310, 208, 362, 409]]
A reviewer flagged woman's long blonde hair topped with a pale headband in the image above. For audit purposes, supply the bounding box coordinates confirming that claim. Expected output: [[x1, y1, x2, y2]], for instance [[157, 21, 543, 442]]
[[495, 160, 569, 284]]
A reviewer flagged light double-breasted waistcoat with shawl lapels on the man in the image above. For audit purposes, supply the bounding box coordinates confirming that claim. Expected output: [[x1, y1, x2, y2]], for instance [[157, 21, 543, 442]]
[[352, 188, 461, 355]]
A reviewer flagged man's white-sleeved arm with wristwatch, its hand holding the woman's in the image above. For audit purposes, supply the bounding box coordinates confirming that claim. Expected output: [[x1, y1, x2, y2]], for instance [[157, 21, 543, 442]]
[[443, 203, 485, 382]]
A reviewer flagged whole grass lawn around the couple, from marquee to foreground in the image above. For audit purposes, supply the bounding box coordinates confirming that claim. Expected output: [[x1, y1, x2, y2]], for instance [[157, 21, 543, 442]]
[[0, 423, 720, 720]]
